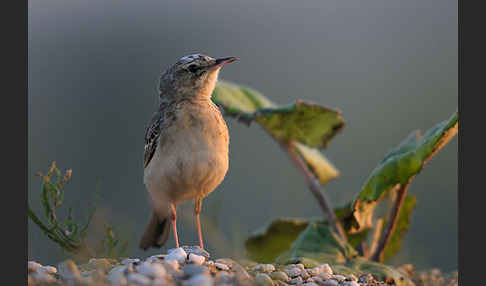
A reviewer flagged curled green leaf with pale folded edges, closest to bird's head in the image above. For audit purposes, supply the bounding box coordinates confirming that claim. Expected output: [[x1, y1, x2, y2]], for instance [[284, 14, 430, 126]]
[[212, 81, 344, 184]]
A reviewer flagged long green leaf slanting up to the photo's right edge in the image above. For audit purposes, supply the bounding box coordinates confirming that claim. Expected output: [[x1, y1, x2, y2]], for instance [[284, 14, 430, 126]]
[[350, 112, 458, 233]]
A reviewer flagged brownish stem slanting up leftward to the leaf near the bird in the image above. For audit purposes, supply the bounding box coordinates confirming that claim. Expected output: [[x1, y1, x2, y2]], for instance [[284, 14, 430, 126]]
[[281, 142, 347, 242]]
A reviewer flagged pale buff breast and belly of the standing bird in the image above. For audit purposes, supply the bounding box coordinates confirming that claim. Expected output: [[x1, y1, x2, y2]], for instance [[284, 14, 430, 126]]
[[144, 103, 229, 204]]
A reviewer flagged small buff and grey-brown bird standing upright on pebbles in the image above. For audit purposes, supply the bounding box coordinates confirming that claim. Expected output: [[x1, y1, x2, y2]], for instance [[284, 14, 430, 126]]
[[139, 53, 238, 250]]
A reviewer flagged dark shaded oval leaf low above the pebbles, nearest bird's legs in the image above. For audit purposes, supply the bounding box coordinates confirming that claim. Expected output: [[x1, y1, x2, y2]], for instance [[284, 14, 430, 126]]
[[245, 218, 308, 263]]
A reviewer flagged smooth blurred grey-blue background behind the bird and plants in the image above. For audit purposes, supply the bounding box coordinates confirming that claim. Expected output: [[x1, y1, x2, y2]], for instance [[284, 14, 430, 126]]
[[28, 0, 458, 271]]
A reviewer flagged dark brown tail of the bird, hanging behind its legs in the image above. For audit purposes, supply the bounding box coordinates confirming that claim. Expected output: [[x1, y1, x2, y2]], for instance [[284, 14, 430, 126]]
[[139, 211, 170, 250]]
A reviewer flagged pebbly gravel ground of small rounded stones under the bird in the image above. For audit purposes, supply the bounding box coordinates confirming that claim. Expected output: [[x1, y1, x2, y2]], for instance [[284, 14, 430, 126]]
[[28, 246, 458, 286]]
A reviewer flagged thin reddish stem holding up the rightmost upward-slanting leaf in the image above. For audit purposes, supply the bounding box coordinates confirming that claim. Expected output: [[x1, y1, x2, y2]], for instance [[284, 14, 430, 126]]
[[371, 183, 413, 262]]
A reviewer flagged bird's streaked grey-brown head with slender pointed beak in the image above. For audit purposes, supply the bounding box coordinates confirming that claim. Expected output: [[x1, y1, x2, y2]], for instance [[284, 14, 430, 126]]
[[159, 54, 237, 98]]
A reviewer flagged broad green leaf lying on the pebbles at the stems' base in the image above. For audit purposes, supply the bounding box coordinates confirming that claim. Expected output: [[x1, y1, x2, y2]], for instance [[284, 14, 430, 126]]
[[277, 222, 413, 286]]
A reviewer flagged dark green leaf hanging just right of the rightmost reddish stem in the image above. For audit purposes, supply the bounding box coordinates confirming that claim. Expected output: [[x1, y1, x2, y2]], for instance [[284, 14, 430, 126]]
[[384, 195, 417, 261]]
